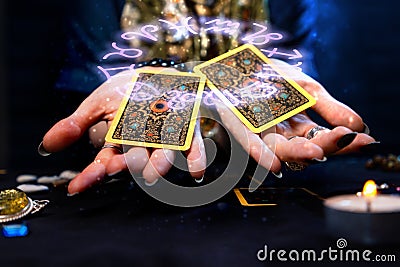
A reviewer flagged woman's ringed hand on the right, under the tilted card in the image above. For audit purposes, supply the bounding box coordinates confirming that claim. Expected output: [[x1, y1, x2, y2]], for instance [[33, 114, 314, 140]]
[[216, 60, 375, 176]]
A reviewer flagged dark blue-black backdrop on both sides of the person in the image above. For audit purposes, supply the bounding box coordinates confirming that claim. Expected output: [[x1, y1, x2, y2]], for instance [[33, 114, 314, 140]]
[[0, 0, 400, 170]]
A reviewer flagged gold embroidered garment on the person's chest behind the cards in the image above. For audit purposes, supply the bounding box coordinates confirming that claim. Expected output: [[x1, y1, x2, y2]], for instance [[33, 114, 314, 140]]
[[121, 0, 268, 61]]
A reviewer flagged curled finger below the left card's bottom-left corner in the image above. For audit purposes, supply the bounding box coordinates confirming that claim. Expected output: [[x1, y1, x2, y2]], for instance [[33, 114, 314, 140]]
[[106, 147, 150, 176]]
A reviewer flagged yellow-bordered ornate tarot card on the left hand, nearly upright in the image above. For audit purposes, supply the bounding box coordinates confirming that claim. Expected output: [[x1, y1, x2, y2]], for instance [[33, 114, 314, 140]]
[[106, 70, 205, 150]]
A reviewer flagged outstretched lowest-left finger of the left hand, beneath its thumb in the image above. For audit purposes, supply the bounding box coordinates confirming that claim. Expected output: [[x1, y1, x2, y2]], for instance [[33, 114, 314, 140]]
[[68, 148, 120, 194]]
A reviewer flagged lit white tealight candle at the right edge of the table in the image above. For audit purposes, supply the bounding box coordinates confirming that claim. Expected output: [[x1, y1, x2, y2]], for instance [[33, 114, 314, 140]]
[[324, 180, 400, 245]]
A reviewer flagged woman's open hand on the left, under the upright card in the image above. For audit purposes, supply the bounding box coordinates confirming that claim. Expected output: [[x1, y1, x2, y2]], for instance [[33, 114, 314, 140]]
[[39, 67, 206, 194]]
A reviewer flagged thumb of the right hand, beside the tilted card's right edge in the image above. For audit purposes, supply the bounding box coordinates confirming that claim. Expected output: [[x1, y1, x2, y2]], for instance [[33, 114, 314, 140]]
[[272, 59, 365, 132]]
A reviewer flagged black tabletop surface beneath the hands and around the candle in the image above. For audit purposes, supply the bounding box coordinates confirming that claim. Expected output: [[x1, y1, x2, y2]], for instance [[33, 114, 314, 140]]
[[0, 155, 400, 266]]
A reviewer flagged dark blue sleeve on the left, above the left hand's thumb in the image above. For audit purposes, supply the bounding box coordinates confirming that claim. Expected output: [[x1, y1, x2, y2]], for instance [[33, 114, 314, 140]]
[[55, 0, 125, 93]]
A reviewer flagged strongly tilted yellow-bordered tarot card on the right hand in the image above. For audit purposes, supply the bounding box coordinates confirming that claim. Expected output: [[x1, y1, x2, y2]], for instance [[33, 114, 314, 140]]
[[194, 44, 315, 133]]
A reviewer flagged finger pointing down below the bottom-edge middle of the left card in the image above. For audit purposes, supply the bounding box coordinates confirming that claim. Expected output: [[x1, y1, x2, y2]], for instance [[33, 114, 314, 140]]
[[143, 149, 175, 184]]
